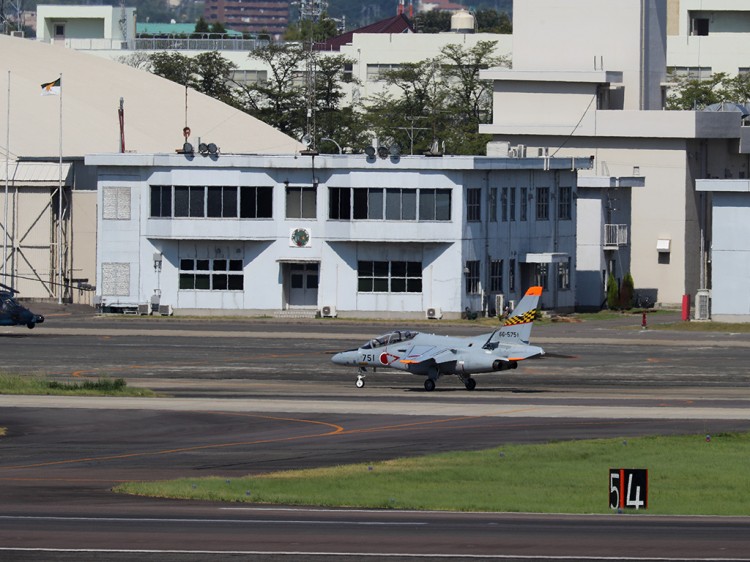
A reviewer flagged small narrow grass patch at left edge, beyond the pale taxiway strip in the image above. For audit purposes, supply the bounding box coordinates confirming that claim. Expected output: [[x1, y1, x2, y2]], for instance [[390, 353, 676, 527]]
[[0, 374, 155, 396]]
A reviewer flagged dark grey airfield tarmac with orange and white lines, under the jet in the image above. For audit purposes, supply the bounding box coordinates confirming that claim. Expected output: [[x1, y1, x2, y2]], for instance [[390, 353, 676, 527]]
[[0, 308, 750, 560]]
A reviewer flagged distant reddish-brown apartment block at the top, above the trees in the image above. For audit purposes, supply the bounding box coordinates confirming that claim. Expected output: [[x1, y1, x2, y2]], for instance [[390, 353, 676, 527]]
[[203, 0, 289, 38]]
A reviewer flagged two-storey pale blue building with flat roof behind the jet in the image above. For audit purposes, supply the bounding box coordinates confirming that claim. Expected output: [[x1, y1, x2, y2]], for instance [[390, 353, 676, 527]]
[[86, 153, 591, 318]]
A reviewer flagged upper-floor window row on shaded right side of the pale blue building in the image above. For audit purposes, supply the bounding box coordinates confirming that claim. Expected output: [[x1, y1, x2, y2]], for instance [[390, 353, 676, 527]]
[[466, 187, 573, 222]]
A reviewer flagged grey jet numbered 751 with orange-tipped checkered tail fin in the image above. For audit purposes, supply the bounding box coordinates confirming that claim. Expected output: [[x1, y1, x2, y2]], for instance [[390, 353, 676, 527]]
[[331, 287, 544, 391]]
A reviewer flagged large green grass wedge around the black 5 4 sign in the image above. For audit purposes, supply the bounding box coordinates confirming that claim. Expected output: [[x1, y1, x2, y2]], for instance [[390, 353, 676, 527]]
[[115, 433, 750, 515]]
